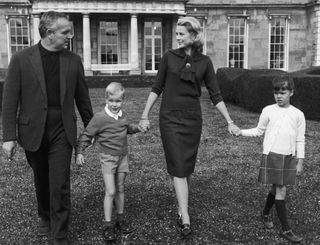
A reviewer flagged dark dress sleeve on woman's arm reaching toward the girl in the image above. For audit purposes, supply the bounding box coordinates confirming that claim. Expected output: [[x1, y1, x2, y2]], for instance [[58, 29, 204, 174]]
[[204, 58, 223, 105]]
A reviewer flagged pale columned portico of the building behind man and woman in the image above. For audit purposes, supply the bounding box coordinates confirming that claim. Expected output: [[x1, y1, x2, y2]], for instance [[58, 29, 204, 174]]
[[32, 0, 185, 75]]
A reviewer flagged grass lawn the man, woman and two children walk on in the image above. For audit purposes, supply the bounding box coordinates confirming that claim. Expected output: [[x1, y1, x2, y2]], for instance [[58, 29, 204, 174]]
[[0, 88, 320, 245]]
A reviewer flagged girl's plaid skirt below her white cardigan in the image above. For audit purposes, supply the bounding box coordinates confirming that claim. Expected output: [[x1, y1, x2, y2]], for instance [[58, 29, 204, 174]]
[[258, 152, 297, 185]]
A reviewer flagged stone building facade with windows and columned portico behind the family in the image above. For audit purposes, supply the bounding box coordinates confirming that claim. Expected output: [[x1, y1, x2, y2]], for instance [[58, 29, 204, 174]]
[[0, 0, 320, 75]]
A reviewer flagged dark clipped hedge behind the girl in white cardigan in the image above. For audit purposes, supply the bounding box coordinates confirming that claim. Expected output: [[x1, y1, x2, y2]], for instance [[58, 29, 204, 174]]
[[217, 68, 320, 120]]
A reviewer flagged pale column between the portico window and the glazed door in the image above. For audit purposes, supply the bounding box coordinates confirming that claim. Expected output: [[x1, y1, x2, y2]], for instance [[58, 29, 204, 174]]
[[130, 14, 141, 74]]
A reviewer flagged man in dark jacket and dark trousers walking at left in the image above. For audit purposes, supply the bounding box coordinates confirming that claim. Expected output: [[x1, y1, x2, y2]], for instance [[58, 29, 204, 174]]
[[2, 11, 93, 245]]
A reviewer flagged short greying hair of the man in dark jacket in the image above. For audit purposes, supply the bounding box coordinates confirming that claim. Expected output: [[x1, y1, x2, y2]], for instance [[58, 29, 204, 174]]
[[39, 11, 69, 38]]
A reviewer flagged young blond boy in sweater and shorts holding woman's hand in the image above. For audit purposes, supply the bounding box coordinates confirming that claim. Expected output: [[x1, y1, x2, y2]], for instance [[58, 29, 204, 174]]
[[76, 82, 143, 241]]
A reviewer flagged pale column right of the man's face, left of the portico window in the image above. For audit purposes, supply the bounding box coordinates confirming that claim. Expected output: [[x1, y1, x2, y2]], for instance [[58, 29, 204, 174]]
[[82, 13, 92, 75]]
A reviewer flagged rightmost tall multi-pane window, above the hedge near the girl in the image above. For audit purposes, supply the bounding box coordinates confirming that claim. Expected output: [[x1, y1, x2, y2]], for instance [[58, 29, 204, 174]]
[[269, 16, 289, 70]]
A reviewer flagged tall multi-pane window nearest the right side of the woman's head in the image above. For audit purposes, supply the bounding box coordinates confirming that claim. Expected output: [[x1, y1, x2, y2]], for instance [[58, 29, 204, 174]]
[[228, 17, 248, 68]]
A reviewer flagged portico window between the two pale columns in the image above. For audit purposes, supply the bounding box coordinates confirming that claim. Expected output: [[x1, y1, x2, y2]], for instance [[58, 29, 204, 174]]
[[99, 21, 119, 64]]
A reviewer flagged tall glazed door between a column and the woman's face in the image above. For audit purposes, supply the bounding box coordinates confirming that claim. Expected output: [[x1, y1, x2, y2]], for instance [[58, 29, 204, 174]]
[[144, 21, 162, 73]]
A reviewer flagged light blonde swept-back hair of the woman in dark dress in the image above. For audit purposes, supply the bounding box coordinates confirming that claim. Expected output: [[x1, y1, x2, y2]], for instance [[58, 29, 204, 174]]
[[177, 16, 204, 53]]
